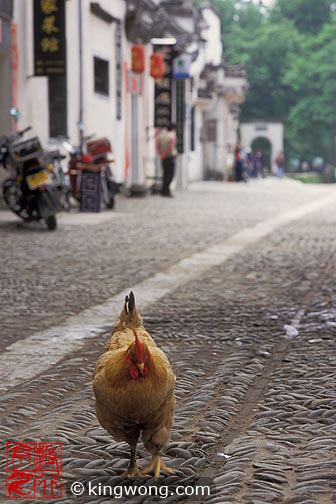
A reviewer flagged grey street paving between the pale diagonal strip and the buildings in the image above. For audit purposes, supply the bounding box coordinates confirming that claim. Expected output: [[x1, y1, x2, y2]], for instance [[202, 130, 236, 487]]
[[0, 178, 335, 351]]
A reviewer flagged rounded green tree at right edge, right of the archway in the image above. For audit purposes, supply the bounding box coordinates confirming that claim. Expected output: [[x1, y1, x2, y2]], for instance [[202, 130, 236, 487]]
[[283, 15, 336, 162]]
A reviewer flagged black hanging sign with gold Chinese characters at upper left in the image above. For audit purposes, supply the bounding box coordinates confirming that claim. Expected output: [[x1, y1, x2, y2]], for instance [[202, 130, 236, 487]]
[[34, 0, 66, 75]]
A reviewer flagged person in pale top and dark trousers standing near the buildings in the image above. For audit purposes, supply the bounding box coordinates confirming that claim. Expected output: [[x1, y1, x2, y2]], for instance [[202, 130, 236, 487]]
[[158, 124, 177, 197]]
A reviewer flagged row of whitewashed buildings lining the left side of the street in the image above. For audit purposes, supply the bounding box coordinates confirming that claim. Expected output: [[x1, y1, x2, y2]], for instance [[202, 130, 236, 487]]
[[0, 0, 246, 188]]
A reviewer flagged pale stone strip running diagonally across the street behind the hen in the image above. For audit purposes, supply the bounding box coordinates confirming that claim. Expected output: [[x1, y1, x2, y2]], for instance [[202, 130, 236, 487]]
[[0, 194, 336, 390]]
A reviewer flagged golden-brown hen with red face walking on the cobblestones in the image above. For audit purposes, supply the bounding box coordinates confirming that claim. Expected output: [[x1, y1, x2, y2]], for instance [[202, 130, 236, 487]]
[[93, 292, 175, 478]]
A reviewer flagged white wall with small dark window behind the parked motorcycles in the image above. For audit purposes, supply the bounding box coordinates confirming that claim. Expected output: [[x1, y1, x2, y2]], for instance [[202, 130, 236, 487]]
[[13, 0, 155, 185]]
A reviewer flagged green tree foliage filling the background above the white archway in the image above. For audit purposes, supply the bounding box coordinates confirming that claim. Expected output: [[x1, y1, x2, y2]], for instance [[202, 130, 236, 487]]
[[195, 0, 336, 162]]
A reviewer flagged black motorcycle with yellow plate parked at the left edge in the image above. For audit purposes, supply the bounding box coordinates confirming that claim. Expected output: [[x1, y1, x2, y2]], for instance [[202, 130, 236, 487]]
[[0, 126, 61, 231]]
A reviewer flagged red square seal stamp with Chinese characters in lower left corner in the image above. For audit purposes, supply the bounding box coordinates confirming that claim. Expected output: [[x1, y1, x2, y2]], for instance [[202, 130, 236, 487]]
[[6, 443, 62, 499]]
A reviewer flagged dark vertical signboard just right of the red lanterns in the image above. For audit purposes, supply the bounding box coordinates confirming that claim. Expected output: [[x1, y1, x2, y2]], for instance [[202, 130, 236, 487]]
[[154, 45, 174, 128]]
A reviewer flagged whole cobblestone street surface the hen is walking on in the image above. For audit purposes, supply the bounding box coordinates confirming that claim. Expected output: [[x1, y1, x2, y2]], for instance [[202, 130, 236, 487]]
[[0, 178, 336, 504]]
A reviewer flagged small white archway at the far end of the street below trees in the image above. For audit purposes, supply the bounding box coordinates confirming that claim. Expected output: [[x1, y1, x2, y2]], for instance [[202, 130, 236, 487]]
[[240, 120, 284, 173]]
